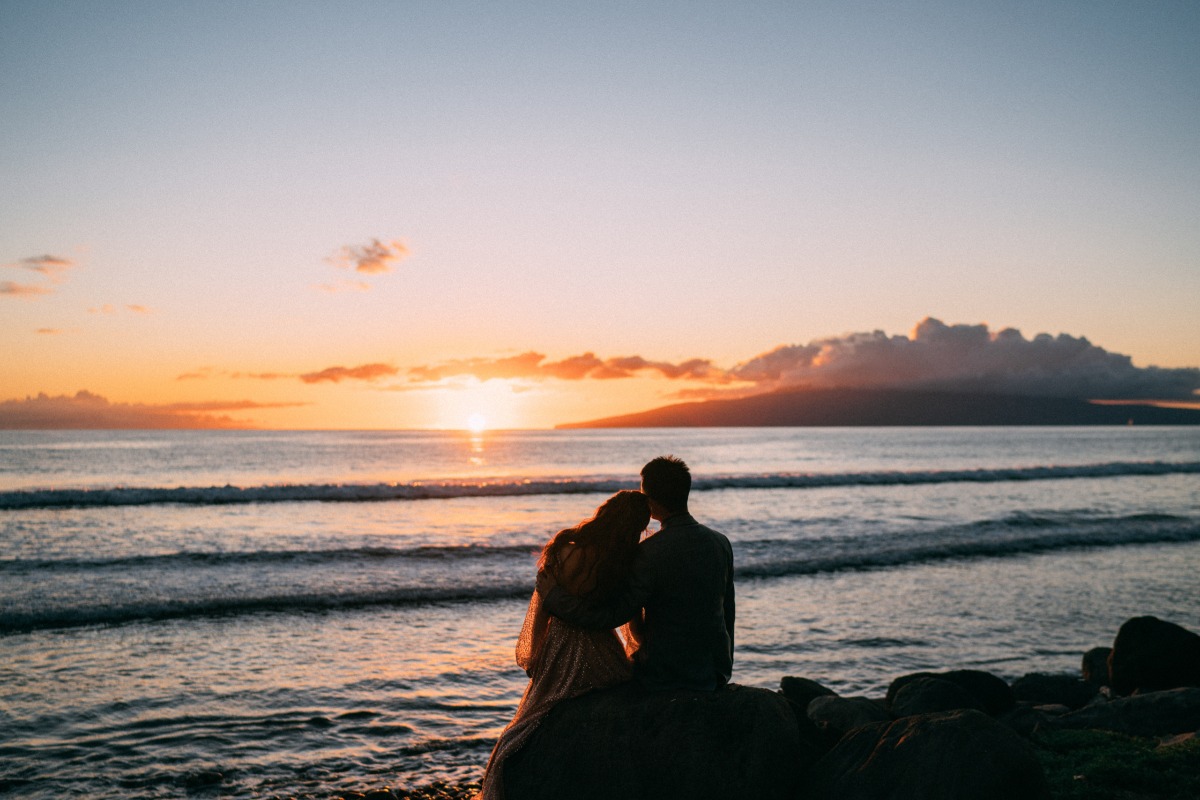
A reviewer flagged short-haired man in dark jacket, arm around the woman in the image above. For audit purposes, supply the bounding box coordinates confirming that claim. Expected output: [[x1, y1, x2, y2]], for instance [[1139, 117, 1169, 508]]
[[538, 456, 734, 691]]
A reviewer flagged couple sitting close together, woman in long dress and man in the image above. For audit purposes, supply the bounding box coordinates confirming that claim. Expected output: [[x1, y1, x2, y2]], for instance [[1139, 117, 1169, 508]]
[[480, 456, 734, 800]]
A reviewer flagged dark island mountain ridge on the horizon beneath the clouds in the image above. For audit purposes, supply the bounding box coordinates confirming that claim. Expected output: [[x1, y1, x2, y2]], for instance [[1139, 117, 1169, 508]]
[[557, 389, 1200, 428]]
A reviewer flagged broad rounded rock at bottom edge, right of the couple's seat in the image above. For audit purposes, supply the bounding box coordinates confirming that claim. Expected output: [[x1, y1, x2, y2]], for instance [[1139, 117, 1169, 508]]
[[804, 710, 1050, 800]]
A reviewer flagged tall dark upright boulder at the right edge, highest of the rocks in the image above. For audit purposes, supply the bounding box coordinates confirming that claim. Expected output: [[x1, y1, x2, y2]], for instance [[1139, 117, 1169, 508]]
[[1109, 616, 1200, 694]]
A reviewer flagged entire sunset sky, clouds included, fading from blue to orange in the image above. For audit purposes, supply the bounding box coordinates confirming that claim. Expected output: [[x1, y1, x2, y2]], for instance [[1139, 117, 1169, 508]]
[[0, 0, 1200, 428]]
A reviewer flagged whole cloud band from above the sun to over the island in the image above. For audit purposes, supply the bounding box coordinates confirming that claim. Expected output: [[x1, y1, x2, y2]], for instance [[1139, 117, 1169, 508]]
[[407, 317, 1200, 399]]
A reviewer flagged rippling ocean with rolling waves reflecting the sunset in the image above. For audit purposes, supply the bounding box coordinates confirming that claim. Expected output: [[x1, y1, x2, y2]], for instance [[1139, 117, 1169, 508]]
[[0, 427, 1200, 798]]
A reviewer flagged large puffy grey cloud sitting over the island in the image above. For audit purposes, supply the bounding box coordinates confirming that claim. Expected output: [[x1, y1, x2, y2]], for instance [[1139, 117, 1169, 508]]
[[730, 318, 1200, 399]]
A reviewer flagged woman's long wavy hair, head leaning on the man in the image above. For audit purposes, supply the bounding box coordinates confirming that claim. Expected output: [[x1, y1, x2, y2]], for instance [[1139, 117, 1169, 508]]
[[538, 489, 650, 600]]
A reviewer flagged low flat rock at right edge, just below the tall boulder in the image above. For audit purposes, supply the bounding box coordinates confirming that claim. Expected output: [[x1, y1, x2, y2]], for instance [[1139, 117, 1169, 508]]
[[1046, 688, 1200, 736]]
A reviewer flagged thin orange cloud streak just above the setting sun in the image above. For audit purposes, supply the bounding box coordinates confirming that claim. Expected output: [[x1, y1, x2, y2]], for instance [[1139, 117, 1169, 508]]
[[408, 350, 728, 383]]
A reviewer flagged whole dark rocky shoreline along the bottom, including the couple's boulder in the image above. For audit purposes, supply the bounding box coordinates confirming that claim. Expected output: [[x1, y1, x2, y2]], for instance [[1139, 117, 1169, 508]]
[[324, 616, 1200, 800]]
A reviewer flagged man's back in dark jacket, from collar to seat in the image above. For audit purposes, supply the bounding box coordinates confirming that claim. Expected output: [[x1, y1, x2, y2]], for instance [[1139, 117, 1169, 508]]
[[632, 513, 734, 690]]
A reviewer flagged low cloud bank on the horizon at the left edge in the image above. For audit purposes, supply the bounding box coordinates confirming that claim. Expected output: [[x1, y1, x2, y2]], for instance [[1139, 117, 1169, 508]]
[[0, 390, 304, 429]]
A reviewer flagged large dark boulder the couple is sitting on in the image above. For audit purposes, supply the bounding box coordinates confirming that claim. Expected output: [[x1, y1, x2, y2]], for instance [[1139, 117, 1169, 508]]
[[504, 684, 818, 800]]
